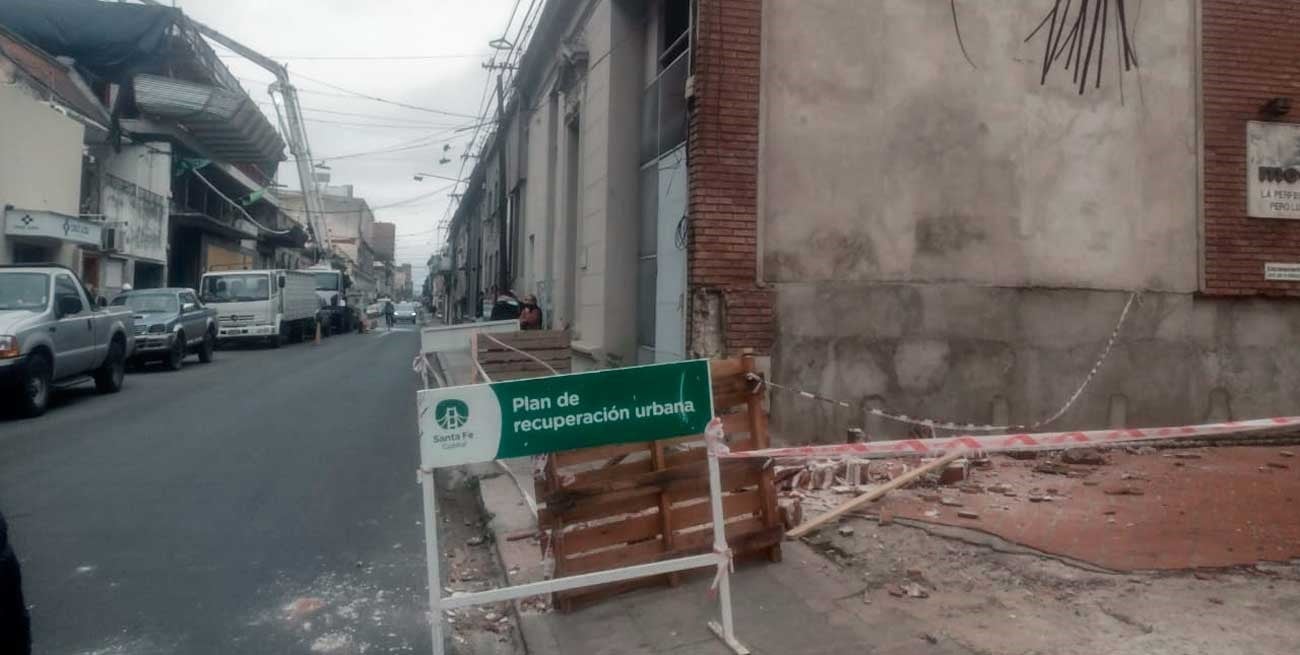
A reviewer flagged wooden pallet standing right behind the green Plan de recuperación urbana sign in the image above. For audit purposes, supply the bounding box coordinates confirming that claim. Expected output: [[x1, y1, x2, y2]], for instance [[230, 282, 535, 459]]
[[533, 357, 784, 611]]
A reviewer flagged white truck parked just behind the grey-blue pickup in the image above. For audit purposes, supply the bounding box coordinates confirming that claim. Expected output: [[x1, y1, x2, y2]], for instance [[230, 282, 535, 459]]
[[199, 269, 321, 348]]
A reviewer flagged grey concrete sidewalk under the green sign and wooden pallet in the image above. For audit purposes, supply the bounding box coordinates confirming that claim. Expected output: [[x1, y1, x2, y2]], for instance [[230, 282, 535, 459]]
[[426, 345, 971, 655]]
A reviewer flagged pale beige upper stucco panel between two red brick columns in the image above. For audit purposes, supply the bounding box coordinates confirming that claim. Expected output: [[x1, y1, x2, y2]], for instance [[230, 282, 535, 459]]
[[761, 0, 1197, 291]]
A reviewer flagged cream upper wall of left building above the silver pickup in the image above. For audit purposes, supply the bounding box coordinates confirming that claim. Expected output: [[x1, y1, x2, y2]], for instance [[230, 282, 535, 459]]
[[0, 78, 85, 272]]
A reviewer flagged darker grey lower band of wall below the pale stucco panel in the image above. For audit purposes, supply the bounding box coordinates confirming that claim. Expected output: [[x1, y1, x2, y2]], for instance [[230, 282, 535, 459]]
[[772, 285, 1300, 441]]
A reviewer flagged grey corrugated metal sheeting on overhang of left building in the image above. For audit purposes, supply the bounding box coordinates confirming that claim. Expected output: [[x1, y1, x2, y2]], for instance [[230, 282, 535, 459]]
[[133, 75, 285, 161]]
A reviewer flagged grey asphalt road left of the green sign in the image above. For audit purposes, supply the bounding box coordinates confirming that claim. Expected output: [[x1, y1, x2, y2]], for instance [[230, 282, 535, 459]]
[[0, 328, 429, 655]]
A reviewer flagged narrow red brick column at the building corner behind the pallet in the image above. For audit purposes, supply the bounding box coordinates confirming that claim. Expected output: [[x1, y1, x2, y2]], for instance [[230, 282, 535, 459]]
[[688, 0, 774, 353]]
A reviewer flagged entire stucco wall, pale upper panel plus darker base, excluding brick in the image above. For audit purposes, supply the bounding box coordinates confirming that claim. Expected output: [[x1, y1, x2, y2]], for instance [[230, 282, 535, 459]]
[[759, 0, 1300, 441]]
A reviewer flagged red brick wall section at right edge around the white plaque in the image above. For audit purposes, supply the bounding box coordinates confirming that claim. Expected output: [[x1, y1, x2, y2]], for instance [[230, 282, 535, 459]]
[[1201, 0, 1300, 296]]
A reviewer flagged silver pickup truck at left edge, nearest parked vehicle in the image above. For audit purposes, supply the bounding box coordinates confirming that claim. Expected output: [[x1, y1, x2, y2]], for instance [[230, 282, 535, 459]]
[[0, 264, 135, 416]]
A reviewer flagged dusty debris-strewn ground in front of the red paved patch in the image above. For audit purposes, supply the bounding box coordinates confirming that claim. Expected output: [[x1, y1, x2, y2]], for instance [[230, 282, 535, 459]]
[[807, 517, 1300, 655]]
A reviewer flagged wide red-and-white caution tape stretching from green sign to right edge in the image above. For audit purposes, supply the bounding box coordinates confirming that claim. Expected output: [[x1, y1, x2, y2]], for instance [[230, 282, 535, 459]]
[[718, 416, 1300, 459]]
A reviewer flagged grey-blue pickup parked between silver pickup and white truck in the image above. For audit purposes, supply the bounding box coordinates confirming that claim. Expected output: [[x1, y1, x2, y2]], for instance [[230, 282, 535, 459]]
[[113, 289, 217, 370]]
